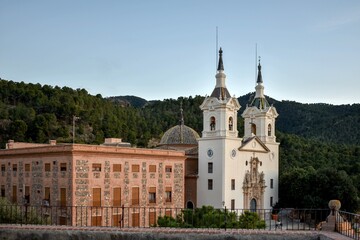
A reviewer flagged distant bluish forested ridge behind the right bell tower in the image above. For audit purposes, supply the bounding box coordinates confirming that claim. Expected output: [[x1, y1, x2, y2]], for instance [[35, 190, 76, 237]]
[[239, 94, 360, 144]]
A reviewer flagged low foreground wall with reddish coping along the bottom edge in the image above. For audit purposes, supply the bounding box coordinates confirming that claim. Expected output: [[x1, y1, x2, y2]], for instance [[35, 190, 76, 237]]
[[0, 224, 351, 240]]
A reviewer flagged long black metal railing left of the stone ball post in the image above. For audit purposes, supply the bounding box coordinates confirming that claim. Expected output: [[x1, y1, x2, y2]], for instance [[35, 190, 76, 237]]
[[0, 205, 330, 230]]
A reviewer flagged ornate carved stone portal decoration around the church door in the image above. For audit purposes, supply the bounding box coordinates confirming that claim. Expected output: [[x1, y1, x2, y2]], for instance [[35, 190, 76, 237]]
[[243, 157, 266, 211]]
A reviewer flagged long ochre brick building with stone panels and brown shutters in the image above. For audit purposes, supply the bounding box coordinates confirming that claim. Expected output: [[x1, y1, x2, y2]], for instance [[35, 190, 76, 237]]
[[0, 141, 185, 226]]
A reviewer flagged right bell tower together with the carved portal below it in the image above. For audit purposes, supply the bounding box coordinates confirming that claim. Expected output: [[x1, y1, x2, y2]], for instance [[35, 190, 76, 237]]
[[242, 60, 279, 209]]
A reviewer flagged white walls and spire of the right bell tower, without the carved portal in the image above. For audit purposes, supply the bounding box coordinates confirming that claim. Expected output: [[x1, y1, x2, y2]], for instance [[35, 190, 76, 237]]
[[242, 60, 279, 209]]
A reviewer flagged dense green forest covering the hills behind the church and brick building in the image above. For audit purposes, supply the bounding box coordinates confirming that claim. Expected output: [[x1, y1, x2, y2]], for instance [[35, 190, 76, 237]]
[[0, 79, 360, 211]]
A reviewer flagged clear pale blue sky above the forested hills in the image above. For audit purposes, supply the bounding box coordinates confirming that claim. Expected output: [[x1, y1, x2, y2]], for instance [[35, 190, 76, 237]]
[[0, 0, 360, 104]]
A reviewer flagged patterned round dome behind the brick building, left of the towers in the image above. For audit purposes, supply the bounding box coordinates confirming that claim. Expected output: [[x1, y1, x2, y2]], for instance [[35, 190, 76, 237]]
[[160, 124, 200, 145]]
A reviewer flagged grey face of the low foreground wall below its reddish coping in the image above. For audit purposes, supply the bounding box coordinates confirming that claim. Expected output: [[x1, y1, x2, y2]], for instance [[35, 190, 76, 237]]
[[0, 229, 336, 240]]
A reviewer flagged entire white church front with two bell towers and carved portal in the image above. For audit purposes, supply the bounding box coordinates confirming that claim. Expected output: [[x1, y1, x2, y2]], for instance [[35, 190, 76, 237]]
[[196, 49, 279, 210]]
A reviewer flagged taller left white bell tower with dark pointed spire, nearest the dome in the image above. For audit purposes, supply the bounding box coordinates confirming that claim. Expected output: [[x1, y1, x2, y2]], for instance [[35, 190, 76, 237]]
[[197, 48, 241, 208]]
